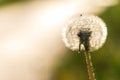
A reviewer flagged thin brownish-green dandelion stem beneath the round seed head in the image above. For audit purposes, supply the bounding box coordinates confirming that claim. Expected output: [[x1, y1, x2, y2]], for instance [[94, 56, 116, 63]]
[[85, 51, 95, 80]]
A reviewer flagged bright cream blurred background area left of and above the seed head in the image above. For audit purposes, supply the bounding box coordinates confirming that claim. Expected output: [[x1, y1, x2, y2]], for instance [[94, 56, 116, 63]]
[[0, 0, 117, 80]]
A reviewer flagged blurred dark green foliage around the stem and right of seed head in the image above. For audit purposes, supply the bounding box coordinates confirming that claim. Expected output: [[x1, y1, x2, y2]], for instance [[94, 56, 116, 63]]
[[52, 0, 120, 80]]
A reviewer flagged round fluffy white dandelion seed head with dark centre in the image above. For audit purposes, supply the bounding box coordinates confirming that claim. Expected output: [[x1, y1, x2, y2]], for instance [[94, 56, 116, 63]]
[[62, 14, 107, 52]]
